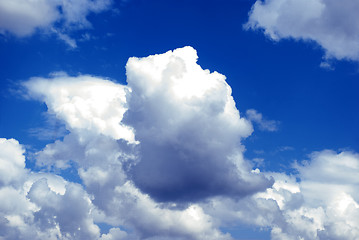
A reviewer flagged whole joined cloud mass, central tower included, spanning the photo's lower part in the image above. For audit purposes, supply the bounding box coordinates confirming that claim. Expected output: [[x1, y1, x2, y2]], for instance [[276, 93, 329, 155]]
[[0, 47, 359, 240]]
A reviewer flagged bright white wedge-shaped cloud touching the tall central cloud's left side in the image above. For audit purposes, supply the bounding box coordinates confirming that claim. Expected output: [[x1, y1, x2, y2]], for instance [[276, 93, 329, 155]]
[[24, 74, 135, 143]]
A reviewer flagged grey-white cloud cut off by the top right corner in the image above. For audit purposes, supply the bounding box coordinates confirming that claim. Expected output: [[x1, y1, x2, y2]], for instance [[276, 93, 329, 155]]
[[245, 0, 359, 62]]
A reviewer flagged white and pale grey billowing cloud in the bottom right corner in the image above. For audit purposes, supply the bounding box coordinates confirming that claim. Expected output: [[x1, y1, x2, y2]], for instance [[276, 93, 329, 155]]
[[205, 150, 359, 240]]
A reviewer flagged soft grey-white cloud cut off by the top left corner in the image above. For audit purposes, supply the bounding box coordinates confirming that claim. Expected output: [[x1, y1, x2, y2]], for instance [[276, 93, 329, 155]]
[[0, 0, 111, 48]]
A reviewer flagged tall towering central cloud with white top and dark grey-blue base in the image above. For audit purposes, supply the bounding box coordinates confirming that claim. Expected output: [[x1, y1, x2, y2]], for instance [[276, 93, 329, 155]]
[[124, 47, 270, 201]]
